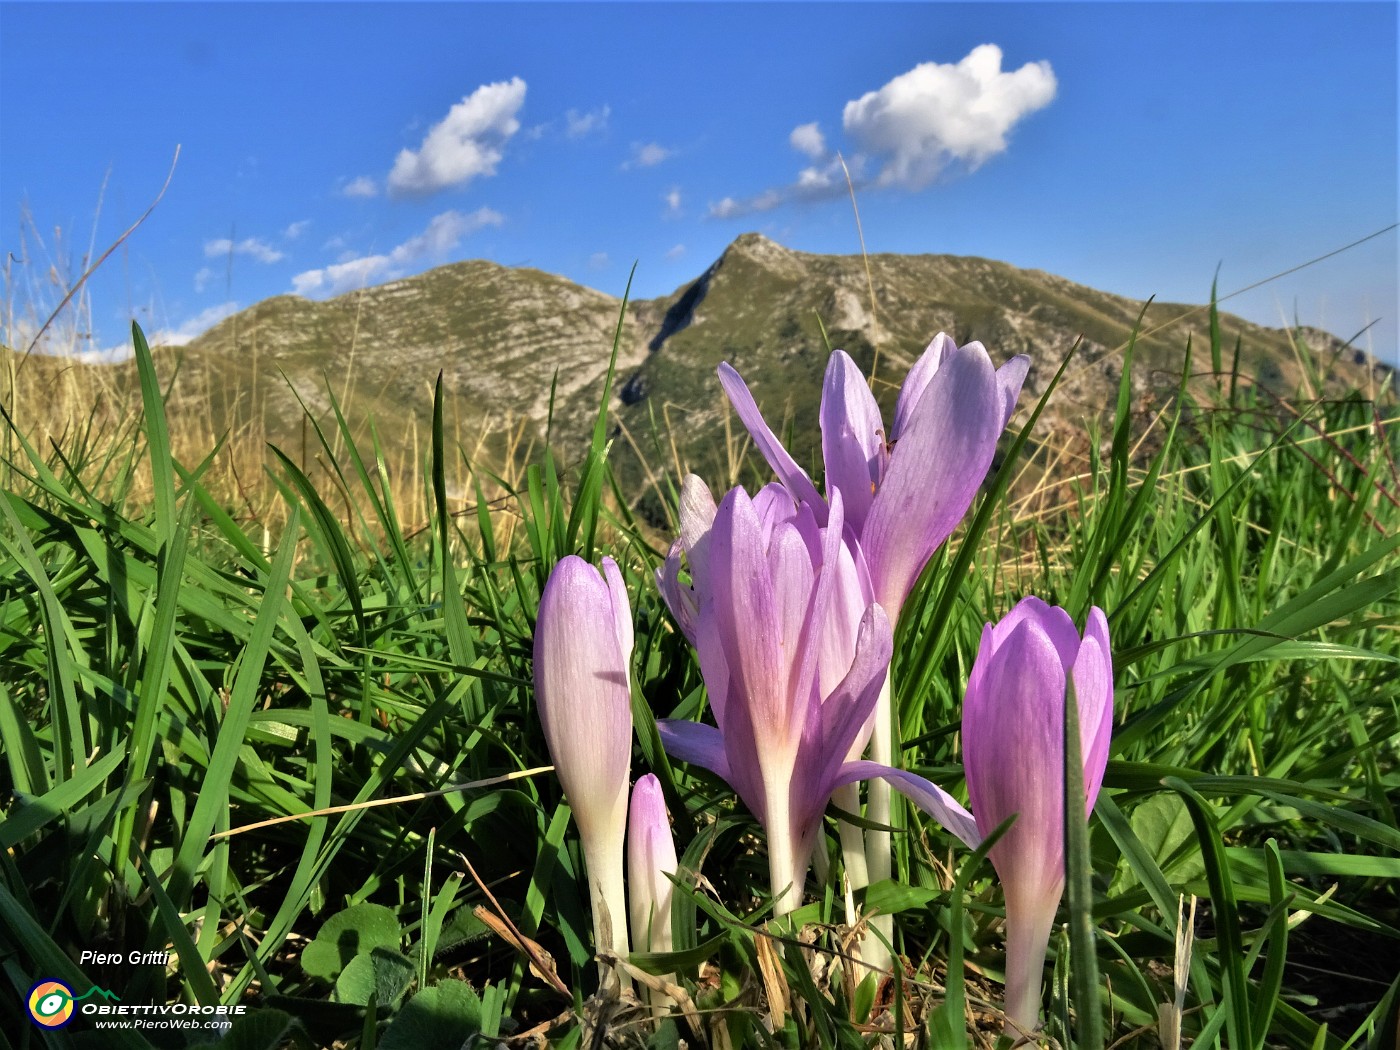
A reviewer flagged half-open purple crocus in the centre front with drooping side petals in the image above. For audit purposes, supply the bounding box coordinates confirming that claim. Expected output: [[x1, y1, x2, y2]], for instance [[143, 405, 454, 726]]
[[659, 479, 979, 914]]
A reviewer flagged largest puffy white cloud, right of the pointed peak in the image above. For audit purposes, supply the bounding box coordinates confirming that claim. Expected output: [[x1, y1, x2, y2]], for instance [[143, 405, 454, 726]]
[[841, 43, 1056, 189]]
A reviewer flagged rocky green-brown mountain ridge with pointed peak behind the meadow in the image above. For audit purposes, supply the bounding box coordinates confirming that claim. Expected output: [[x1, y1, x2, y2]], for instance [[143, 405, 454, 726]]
[[10, 232, 1394, 523]]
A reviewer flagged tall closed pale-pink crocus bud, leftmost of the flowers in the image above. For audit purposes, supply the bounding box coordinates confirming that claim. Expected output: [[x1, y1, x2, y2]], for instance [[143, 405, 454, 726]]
[[535, 554, 633, 974]]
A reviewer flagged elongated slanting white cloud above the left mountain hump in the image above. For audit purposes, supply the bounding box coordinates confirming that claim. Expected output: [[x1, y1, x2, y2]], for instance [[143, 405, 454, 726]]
[[388, 77, 525, 195]]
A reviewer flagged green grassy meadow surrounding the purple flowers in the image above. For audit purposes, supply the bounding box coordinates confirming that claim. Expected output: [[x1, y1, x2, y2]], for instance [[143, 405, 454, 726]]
[[0, 281, 1400, 1050]]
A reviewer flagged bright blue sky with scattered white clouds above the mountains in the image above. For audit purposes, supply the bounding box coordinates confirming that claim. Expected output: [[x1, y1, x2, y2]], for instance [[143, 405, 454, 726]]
[[0, 3, 1400, 360]]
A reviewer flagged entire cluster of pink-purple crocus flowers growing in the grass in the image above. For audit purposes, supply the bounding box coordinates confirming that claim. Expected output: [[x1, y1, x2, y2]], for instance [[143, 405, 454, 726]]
[[535, 335, 1113, 1030]]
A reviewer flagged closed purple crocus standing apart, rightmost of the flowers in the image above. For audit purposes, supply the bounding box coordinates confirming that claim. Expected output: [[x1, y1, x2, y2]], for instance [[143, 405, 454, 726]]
[[962, 596, 1113, 1032]]
